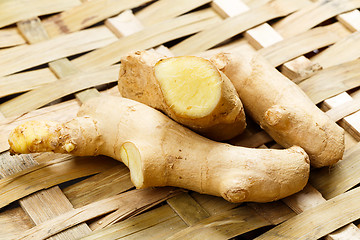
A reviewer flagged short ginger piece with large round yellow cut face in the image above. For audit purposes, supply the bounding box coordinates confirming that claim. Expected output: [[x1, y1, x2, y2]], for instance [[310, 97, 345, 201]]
[[119, 51, 246, 140]]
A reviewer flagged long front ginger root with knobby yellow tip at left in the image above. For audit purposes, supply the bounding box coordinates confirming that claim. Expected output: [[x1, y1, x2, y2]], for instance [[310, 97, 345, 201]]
[[9, 96, 310, 202]]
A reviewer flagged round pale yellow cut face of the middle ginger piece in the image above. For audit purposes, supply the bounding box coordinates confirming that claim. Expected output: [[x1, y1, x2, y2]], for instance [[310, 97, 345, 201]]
[[155, 56, 222, 118]]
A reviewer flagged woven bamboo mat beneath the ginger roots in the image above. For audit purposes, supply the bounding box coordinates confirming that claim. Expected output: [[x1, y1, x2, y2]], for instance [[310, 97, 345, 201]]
[[0, 0, 360, 239]]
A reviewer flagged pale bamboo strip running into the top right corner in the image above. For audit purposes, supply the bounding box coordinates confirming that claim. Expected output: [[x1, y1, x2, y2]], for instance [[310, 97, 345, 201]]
[[274, 0, 360, 38]]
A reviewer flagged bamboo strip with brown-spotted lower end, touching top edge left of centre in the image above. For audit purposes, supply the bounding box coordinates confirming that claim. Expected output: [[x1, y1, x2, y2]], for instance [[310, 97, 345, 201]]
[[44, 0, 150, 37]]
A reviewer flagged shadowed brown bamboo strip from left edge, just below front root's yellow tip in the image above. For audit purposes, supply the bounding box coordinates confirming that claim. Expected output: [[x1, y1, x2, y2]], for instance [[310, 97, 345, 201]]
[[0, 156, 118, 208]]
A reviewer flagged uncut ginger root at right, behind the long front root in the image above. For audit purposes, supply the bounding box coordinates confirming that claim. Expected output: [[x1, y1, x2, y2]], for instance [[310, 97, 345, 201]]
[[211, 51, 345, 167]]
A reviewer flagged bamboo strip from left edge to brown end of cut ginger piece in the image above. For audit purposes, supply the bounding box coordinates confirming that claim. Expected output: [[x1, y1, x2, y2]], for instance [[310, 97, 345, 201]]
[[0, 65, 119, 117]]
